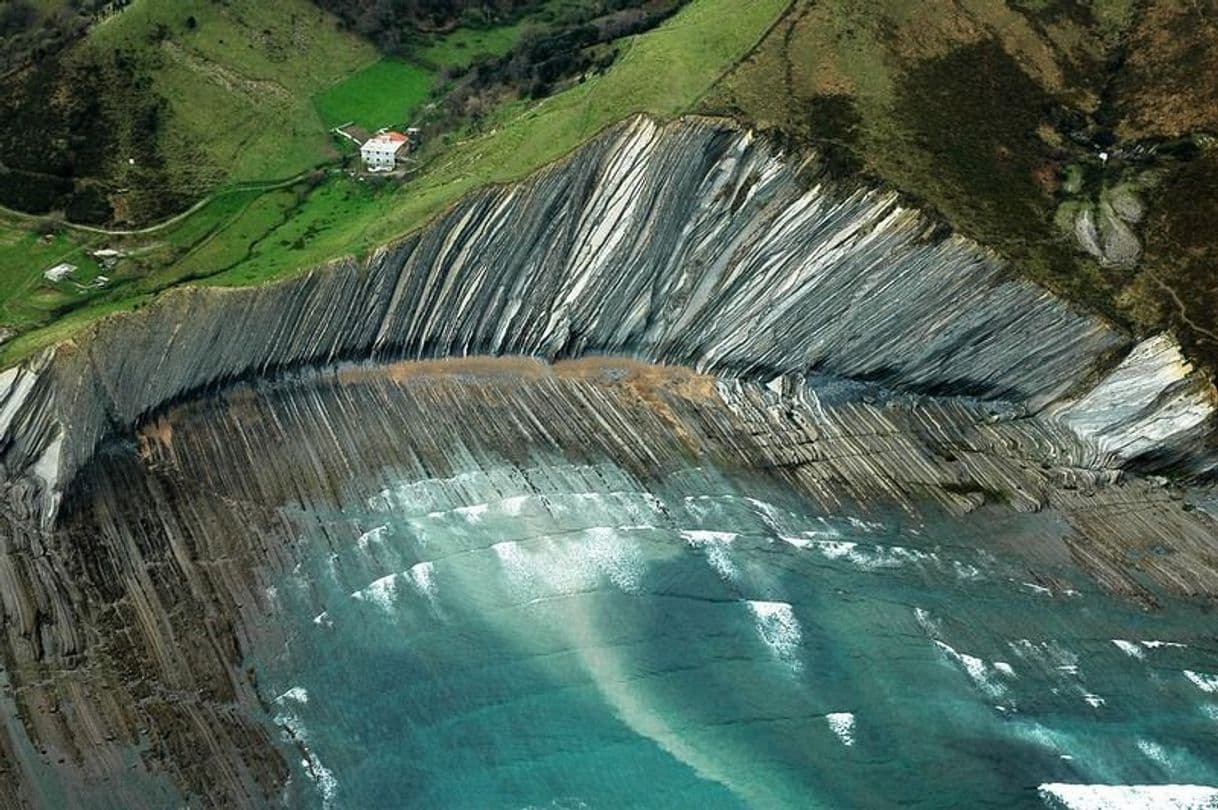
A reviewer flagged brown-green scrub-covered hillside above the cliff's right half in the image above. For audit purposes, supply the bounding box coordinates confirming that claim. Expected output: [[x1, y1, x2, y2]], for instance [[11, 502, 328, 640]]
[[703, 0, 1218, 369]]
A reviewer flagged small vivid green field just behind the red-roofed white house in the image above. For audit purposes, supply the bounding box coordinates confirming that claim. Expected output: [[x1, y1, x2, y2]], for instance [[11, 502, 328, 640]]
[[313, 57, 436, 132]]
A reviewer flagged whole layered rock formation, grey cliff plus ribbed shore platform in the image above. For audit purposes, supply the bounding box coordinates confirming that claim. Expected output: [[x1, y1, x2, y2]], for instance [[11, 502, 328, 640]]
[[0, 118, 1218, 806]]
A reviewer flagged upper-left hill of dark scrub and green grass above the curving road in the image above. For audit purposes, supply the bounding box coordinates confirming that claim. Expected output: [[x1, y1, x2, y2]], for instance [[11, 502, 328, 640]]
[[0, 0, 378, 225]]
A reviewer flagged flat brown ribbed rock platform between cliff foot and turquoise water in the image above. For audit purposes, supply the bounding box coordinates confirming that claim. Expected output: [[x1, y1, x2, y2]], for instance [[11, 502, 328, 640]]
[[2, 361, 1218, 806]]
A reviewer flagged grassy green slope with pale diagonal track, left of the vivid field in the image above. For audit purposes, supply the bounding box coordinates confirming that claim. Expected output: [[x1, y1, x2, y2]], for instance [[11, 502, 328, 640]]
[[83, 0, 378, 188]]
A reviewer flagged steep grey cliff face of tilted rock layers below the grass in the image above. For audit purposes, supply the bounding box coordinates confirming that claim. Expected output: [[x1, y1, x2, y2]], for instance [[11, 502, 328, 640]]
[[0, 117, 1218, 524]]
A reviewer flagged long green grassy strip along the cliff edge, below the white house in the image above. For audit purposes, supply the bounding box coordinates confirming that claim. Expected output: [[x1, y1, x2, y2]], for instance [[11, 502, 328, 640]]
[[0, 0, 788, 363]]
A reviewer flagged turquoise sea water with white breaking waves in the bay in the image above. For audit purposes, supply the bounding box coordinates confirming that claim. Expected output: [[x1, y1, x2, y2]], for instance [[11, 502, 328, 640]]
[[253, 459, 1218, 810]]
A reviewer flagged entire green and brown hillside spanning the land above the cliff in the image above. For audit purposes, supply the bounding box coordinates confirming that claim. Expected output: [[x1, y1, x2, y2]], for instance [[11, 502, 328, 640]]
[[0, 0, 1218, 382]]
